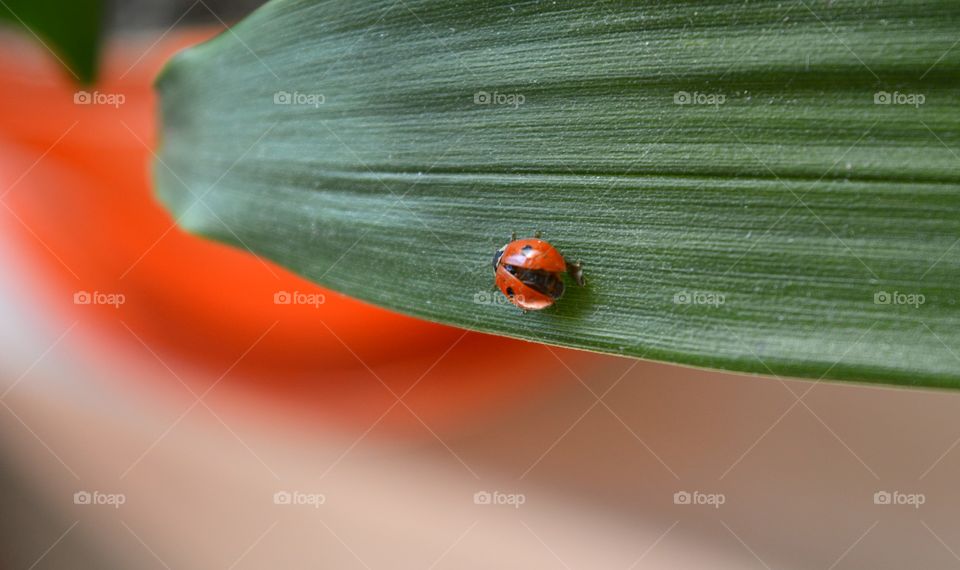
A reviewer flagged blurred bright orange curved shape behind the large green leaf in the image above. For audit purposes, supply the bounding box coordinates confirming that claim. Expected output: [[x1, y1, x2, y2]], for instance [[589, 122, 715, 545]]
[[0, 25, 612, 430]]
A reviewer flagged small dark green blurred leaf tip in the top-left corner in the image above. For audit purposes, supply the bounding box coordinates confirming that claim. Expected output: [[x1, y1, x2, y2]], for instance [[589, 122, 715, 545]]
[[0, 0, 104, 83]]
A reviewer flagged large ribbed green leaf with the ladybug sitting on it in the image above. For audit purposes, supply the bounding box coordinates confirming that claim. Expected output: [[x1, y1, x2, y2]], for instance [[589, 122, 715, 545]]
[[154, 0, 960, 387]]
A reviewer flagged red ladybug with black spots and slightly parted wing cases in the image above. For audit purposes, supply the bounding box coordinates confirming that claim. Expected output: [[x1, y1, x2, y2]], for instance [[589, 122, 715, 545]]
[[493, 232, 584, 311]]
